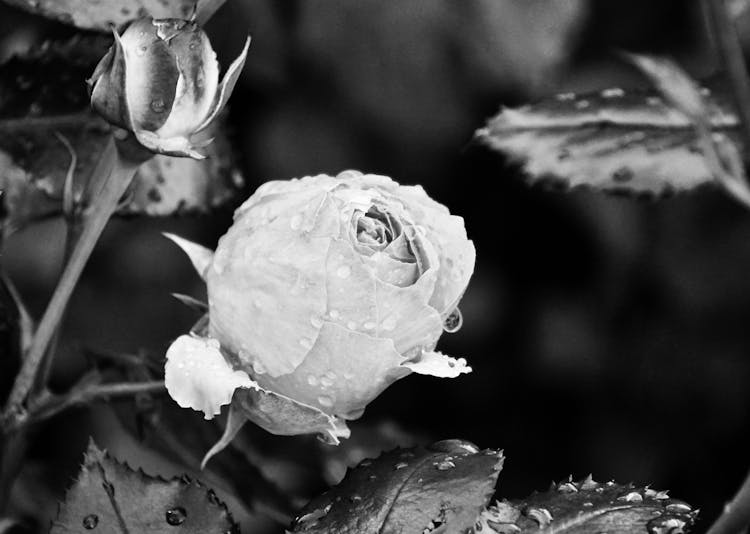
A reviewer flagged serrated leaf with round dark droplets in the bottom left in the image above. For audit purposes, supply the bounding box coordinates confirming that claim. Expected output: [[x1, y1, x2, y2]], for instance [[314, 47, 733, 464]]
[[50, 442, 237, 534]]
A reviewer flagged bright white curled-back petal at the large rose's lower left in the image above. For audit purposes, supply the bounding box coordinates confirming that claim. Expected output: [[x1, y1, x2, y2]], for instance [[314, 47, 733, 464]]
[[164, 336, 257, 419]]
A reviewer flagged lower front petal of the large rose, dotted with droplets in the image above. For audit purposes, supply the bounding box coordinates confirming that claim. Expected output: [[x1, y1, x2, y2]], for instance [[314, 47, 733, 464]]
[[259, 323, 408, 419]]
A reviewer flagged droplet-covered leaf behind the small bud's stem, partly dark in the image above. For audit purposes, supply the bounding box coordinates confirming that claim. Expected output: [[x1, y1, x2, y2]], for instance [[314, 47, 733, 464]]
[[0, 37, 242, 234]]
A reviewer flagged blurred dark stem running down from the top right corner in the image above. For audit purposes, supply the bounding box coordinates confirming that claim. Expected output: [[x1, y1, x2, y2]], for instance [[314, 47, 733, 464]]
[[705, 0, 750, 165]]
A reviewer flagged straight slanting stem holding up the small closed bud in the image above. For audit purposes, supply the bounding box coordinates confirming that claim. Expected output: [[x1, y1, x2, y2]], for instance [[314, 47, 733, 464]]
[[5, 139, 140, 417]]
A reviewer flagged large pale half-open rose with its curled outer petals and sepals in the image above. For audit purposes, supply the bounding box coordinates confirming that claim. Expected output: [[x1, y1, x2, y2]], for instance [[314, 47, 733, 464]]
[[165, 171, 475, 466]]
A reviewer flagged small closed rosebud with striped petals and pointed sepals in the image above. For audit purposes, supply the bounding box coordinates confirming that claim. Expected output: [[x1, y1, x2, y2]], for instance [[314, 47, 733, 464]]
[[88, 17, 250, 159]]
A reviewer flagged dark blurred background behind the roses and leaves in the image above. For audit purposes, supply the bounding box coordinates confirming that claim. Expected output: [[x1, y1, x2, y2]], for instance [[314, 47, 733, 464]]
[[0, 0, 750, 532]]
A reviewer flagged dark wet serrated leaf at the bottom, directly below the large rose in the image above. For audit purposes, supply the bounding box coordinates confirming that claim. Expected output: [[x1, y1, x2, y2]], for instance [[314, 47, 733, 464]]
[[291, 440, 503, 534]]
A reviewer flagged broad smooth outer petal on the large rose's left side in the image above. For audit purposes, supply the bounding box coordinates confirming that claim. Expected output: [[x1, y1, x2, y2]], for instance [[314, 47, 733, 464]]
[[207, 225, 330, 376]]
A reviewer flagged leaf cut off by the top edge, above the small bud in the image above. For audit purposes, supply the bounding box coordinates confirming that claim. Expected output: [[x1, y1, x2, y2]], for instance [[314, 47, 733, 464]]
[[0, 0, 196, 32]]
